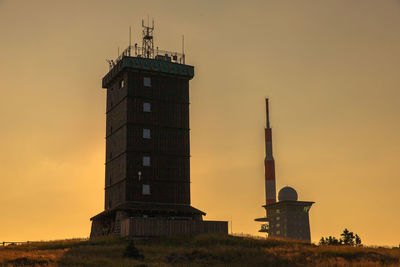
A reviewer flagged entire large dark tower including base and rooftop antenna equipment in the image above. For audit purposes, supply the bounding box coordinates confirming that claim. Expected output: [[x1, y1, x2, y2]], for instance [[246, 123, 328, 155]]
[[91, 22, 227, 237]]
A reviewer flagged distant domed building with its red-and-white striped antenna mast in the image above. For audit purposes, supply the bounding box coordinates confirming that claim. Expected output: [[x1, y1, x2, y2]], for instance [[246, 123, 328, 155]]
[[255, 99, 314, 242]]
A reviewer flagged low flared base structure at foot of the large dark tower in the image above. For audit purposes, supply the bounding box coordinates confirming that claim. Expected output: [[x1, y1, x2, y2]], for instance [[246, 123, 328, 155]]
[[90, 202, 228, 238]]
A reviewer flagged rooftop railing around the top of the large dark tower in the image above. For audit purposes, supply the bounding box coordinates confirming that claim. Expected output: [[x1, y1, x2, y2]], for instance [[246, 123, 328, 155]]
[[107, 44, 185, 70]]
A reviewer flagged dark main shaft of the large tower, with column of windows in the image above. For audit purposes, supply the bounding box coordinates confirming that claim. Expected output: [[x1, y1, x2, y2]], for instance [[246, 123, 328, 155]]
[[103, 57, 193, 211]]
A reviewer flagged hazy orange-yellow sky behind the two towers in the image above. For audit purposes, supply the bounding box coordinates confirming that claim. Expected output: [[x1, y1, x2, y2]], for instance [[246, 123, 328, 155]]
[[0, 0, 400, 245]]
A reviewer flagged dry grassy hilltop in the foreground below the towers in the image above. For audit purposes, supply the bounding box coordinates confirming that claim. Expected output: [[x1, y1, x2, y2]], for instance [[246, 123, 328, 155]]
[[0, 235, 400, 266]]
